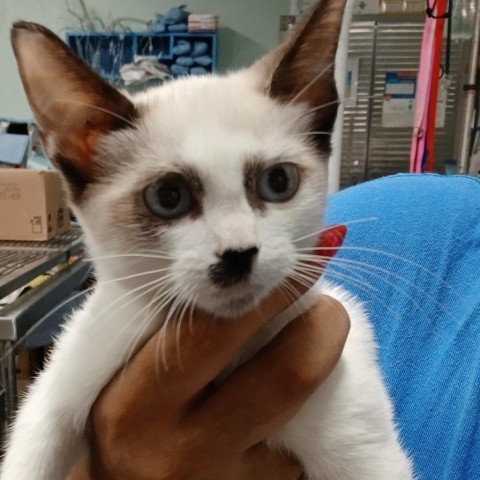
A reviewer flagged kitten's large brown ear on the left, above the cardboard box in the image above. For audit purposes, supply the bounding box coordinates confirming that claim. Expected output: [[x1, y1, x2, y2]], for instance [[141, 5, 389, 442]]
[[11, 22, 136, 198]]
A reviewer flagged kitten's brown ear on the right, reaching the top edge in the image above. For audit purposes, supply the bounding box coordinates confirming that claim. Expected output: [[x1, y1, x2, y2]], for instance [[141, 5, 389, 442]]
[[252, 0, 346, 141]]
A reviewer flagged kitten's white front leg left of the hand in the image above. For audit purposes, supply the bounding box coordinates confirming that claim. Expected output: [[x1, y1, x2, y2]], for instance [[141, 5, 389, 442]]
[[0, 288, 161, 480]]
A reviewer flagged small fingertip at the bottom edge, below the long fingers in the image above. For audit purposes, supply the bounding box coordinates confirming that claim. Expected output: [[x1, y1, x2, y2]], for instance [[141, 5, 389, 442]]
[[242, 443, 303, 480]]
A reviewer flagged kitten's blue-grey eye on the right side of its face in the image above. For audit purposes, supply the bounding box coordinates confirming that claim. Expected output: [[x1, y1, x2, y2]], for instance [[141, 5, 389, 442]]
[[257, 163, 300, 203]]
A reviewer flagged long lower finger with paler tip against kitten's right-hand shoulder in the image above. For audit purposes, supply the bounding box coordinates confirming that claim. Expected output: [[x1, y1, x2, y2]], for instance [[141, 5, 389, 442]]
[[189, 296, 350, 448]]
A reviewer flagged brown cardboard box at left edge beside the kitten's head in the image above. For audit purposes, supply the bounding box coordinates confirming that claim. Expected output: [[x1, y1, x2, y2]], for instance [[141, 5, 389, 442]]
[[0, 168, 70, 244]]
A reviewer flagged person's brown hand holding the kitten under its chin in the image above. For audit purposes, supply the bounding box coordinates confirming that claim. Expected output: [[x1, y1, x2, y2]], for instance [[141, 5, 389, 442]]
[[70, 296, 349, 480]]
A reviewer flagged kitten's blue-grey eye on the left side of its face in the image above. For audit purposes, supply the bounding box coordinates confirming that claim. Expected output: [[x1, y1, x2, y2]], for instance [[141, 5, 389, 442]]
[[144, 175, 193, 220]]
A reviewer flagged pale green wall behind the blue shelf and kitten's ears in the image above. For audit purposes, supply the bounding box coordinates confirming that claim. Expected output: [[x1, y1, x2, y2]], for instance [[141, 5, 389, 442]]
[[0, 0, 290, 119]]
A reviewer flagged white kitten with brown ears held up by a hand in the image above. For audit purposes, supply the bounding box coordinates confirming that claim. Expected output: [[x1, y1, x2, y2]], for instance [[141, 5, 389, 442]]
[[0, 0, 412, 480]]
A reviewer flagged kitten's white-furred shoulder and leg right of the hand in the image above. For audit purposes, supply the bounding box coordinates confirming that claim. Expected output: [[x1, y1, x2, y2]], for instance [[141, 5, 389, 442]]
[[272, 285, 414, 480]]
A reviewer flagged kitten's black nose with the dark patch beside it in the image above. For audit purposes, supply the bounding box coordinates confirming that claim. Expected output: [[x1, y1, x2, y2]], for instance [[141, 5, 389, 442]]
[[209, 247, 258, 287]]
